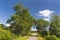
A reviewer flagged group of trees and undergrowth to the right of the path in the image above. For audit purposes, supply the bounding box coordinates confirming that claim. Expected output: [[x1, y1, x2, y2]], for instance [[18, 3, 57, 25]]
[[36, 14, 60, 40]]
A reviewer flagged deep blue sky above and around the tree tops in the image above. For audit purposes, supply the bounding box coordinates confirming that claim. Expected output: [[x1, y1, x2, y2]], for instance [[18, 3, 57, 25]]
[[0, 0, 60, 24]]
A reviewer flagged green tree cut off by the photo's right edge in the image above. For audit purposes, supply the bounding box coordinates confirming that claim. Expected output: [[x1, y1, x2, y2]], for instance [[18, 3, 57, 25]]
[[50, 15, 60, 35]]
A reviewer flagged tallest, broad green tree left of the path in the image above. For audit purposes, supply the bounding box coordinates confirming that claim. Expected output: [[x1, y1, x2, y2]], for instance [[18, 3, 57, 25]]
[[7, 4, 34, 34]]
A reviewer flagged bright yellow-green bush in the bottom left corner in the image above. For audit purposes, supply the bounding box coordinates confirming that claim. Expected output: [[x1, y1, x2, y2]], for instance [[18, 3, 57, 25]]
[[0, 29, 15, 40]]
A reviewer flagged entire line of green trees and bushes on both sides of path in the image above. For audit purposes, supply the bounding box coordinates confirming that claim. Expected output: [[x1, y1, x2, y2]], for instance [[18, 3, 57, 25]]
[[0, 4, 60, 40]]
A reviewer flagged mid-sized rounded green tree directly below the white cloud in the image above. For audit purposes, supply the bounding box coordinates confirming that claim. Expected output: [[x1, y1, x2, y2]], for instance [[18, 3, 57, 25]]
[[36, 19, 49, 35]]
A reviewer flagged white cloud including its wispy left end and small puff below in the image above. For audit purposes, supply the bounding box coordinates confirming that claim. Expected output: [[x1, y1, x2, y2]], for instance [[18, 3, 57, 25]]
[[37, 10, 54, 21]]
